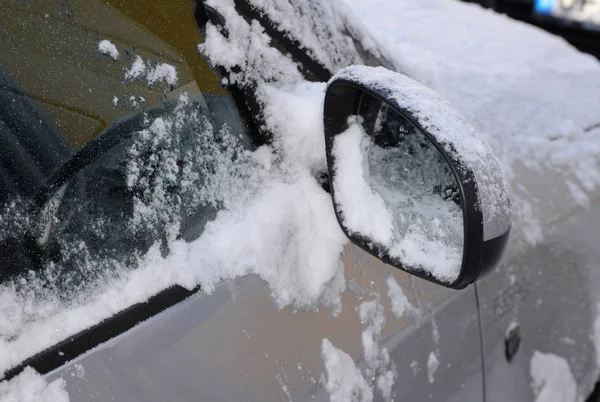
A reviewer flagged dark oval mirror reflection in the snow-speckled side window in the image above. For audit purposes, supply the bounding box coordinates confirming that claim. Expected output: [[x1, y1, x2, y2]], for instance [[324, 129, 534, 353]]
[[37, 95, 254, 289]]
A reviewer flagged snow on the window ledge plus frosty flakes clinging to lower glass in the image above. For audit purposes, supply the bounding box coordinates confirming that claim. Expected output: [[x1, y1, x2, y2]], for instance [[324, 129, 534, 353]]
[[0, 80, 347, 371]]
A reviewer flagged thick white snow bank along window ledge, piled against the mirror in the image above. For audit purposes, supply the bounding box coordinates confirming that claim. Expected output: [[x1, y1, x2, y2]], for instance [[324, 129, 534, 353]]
[[0, 83, 347, 372]]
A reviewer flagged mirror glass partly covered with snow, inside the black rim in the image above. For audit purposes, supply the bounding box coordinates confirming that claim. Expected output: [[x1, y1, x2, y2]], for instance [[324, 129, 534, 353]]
[[333, 93, 464, 283]]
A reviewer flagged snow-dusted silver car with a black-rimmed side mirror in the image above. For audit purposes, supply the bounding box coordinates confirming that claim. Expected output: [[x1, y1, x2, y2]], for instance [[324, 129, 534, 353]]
[[0, 0, 600, 401]]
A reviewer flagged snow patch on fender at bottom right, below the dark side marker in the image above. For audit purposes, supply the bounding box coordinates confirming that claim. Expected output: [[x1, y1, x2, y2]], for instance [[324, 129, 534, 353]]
[[529, 351, 579, 402]]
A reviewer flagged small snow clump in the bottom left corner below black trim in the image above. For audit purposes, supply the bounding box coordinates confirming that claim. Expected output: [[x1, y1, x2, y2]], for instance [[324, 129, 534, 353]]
[[0, 367, 69, 402]]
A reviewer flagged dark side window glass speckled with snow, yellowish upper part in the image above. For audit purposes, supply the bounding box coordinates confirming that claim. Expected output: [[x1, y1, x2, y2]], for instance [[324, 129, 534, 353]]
[[0, 0, 252, 284]]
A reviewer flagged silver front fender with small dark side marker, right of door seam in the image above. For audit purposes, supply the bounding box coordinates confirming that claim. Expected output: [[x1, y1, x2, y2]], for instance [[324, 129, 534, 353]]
[[477, 167, 600, 401]]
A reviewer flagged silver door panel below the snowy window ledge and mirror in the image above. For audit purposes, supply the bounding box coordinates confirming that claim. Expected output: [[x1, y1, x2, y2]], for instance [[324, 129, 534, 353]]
[[47, 245, 483, 401]]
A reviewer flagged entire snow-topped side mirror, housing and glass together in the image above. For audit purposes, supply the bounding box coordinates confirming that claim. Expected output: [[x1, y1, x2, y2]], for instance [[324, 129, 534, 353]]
[[324, 66, 511, 289]]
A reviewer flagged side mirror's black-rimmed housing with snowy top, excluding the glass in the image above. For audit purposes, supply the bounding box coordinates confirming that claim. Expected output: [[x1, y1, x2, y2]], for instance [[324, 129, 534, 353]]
[[324, 66, 511, 289]]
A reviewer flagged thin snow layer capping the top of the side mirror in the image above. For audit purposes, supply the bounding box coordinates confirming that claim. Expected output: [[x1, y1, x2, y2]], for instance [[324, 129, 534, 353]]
[[330, 66, 511, 240]]
